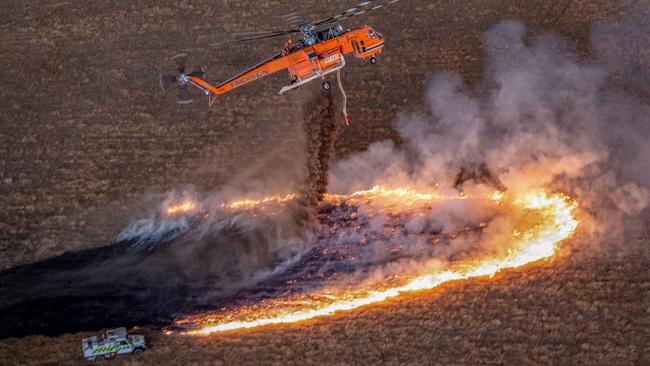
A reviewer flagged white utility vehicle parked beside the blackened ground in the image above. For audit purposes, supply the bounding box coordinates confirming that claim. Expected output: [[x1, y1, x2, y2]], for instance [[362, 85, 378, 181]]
[[81, 327, 147, 361]]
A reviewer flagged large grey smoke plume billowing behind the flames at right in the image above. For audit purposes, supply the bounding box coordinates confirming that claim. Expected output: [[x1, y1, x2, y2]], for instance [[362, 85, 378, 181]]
[[330, 18, 650, 266]]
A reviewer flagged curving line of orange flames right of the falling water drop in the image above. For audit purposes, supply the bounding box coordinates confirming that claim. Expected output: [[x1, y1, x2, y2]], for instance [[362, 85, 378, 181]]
[[179, 186, 578, 335]]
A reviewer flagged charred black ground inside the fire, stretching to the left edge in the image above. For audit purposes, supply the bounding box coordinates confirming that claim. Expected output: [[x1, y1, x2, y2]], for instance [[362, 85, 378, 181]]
[[0, 199, 466, 338]]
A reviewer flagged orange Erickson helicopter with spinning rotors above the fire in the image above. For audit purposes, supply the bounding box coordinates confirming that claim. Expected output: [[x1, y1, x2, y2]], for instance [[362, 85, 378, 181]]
[[167, 0, 399, 125]]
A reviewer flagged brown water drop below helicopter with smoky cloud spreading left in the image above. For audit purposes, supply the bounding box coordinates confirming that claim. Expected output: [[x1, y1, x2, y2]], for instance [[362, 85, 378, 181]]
[[110, 94, 338, 289]]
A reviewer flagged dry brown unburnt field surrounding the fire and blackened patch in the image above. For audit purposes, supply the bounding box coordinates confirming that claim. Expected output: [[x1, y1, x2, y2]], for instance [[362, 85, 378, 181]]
[[0, 0, 650, 365]]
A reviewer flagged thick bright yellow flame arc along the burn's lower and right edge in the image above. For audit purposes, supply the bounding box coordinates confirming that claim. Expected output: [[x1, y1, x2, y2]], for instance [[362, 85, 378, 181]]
[[185, 187, 578, 335]]
